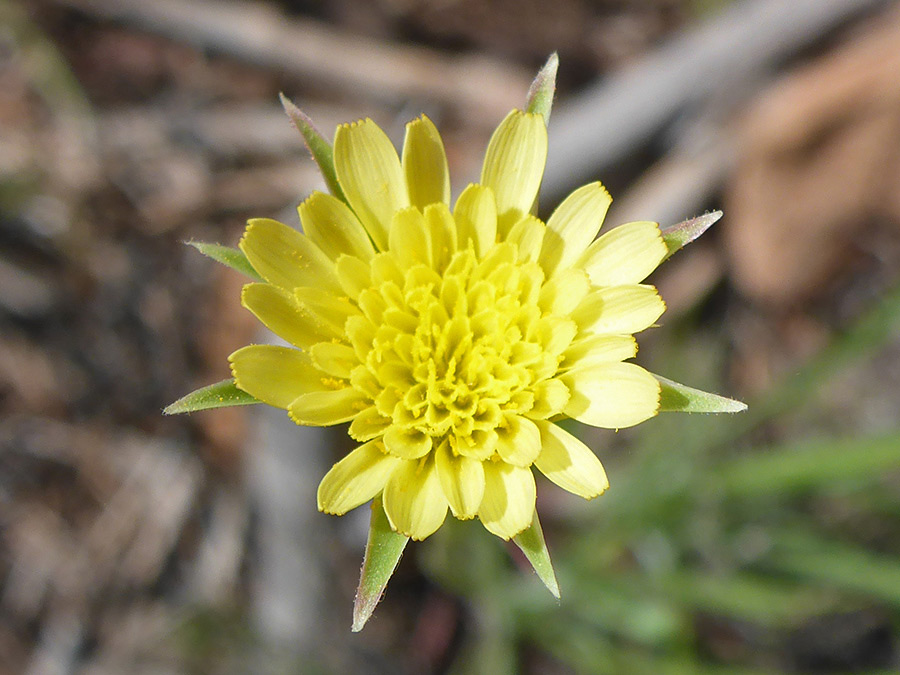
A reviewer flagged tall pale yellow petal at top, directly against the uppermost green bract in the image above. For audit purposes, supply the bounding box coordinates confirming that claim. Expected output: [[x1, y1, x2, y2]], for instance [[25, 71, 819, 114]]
[[481, 110, 547, 235]]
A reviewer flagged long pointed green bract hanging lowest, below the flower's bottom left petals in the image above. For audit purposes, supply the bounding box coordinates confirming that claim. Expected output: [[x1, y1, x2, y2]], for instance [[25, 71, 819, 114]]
[[351, 496, 409, 633]]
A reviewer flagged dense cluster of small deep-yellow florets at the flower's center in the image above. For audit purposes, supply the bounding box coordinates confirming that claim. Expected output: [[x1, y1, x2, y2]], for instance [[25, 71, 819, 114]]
[[348, 243, 574, 459]]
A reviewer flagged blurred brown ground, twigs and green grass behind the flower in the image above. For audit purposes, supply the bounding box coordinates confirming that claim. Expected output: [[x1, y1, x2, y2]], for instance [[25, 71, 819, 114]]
[[0, 0, 900, 675]]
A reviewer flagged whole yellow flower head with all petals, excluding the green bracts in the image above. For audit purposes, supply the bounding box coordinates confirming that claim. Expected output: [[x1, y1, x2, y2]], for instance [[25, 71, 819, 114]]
[[230, 110, 668, 539]]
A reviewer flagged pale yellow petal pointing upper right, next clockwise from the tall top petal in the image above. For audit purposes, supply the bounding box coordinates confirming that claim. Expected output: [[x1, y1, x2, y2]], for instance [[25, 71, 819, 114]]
[[540, 183, 612, 277]]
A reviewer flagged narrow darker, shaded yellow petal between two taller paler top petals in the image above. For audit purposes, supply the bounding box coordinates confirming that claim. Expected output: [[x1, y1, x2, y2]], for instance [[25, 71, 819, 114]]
[[402, 115, 450, 209]]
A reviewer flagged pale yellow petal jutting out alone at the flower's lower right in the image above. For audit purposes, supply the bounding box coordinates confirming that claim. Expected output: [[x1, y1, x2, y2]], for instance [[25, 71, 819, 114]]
[[534, 421, 609, 499]]
